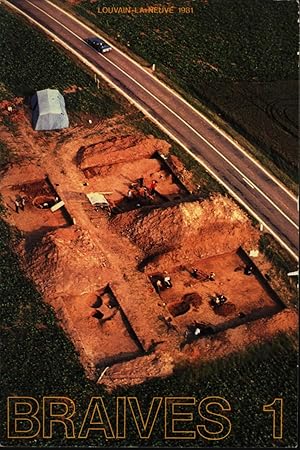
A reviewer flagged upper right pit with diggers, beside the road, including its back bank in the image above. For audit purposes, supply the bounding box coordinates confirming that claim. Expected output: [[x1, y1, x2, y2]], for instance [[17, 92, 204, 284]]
[[76, 135, 189, 213]]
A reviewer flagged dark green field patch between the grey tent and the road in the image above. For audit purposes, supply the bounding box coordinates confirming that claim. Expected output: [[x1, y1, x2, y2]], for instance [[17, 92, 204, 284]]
[[0, 7, 122, 119]]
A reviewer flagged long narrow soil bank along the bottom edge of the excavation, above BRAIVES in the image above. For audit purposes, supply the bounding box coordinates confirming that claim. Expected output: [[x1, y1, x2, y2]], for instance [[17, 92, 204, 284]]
[[100, 309, 298, 391]]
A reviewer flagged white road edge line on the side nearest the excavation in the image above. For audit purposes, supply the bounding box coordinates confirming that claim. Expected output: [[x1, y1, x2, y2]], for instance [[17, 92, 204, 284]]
[[2, 0, 299, 261]]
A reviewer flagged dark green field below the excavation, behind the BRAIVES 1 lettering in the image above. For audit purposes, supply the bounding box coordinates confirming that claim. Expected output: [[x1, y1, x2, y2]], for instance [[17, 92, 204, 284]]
[[0, 215, 297, 447]]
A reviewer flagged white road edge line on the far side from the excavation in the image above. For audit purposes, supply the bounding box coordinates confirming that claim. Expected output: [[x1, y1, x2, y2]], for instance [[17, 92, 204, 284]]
[[45, 0, 297, 202]]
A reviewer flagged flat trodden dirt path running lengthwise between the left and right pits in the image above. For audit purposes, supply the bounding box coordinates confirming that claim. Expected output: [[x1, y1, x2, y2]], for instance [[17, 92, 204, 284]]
[[32, 119, 183, 351]]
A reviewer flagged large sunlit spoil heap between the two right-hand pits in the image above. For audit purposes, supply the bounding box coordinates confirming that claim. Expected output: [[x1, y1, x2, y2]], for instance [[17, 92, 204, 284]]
[[112, 194, 259, 259]]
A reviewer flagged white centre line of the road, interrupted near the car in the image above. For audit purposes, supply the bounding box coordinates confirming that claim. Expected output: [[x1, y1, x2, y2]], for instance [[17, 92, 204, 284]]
[[13, 0, 299, 230]]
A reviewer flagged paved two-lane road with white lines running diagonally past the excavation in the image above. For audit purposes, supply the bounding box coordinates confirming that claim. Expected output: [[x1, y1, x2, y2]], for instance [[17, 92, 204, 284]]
[[4, 0, 299, 259]]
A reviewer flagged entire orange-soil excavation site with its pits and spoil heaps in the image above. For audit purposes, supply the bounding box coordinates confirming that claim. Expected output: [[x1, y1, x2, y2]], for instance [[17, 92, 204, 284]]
[[1, 112, 296, 390]]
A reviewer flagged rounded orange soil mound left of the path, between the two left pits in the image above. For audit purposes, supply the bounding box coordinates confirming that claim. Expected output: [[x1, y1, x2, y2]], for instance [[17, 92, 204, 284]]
[[26, 227, 106, 295]]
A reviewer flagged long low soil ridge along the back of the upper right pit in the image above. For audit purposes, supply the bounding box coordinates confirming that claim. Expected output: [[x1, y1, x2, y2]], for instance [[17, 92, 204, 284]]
[[77, 135, 170, 170]]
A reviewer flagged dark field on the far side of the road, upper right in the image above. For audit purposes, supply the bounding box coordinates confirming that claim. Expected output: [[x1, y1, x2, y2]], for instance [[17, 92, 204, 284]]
[[67, 0, 298, 183]]
